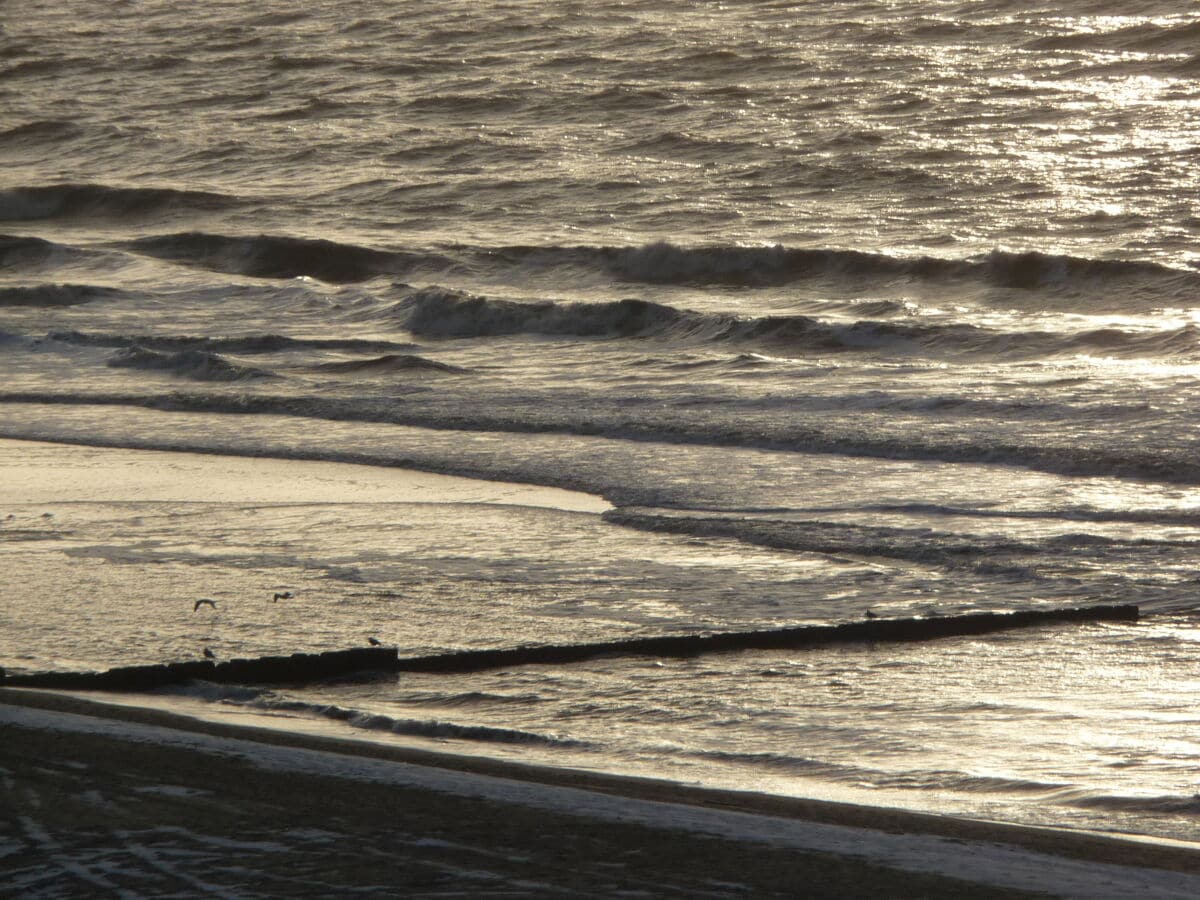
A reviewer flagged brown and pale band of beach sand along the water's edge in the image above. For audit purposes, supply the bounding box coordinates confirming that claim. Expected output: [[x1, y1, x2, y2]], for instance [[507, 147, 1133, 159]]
[[0, 689, 1200, 896]]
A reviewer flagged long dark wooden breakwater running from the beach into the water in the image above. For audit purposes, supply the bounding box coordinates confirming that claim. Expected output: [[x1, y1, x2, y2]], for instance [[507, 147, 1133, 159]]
[[0, 605, 1139, 691]]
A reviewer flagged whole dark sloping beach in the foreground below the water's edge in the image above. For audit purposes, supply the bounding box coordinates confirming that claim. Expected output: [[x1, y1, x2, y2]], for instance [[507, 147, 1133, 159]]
[[0, 689, 1200, 898]]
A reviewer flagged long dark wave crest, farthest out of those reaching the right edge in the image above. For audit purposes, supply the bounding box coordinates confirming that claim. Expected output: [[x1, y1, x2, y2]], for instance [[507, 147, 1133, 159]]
[[105, 234, 1200, 305]]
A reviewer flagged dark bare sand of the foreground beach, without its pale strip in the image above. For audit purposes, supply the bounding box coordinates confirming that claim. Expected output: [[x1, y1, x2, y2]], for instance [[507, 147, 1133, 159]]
[[0, 690, 1200, 898]]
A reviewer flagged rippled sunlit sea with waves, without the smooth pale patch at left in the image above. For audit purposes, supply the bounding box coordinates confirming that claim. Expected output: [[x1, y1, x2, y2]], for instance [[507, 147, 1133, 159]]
[[0, 0, 1200, 840]]
